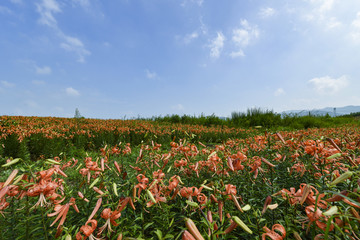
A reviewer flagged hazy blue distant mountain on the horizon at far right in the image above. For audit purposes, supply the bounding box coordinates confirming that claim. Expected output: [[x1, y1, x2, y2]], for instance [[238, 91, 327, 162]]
[[281, 106, 360, 117]]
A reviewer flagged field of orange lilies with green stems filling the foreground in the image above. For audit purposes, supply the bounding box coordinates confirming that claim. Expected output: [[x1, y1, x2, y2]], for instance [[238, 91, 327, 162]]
[[0, 116, 360, 240]]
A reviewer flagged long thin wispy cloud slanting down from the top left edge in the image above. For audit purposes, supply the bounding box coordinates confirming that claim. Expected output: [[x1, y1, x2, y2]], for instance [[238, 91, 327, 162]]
[[36, 0, 91, 63]]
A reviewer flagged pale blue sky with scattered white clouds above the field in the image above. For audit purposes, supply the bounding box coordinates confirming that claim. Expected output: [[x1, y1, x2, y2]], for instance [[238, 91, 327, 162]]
[[0, 0, 360, 119]]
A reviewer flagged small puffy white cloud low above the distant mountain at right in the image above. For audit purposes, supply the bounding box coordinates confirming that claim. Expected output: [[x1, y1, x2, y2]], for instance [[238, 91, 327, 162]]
[[308, 75, 349, 95]]
